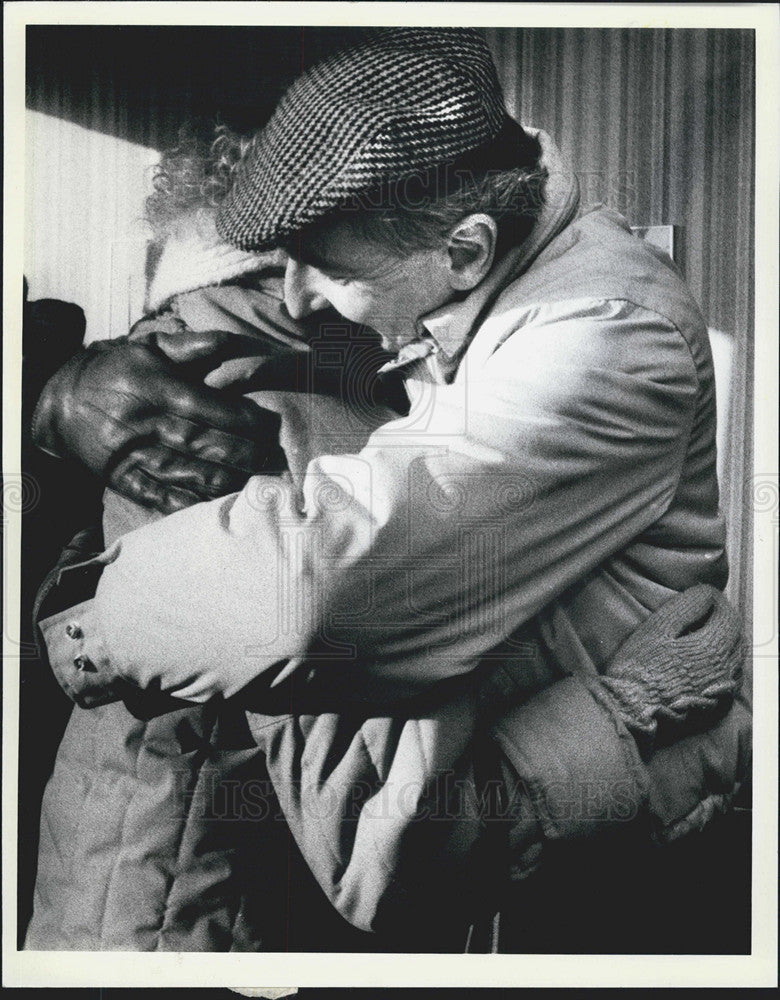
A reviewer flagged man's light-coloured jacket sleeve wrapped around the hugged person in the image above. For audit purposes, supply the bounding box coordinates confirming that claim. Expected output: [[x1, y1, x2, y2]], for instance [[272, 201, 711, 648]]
[[38, 308, 708, 702]]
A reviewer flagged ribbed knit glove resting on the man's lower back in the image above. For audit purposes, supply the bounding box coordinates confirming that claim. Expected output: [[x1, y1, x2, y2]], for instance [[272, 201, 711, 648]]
[[601, 584, 746, 749]]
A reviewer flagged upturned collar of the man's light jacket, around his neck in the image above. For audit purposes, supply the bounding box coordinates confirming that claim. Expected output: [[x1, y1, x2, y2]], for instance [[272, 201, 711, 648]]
[[380, 126, 580, 382]]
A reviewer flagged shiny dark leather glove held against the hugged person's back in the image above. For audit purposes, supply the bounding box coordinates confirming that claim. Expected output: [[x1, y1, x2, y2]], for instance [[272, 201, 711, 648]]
[[33, 330, 286, 513]]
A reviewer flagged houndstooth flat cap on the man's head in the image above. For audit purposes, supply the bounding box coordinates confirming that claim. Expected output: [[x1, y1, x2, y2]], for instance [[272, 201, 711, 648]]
[[217, 28, 522, 251]]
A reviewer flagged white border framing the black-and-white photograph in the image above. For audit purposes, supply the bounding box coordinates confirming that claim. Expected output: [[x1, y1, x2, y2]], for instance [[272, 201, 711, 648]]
[[2, 0, 780, 987]]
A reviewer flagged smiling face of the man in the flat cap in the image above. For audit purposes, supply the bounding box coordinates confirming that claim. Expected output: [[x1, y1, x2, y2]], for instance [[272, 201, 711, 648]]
[[284, 223, 453, 352]]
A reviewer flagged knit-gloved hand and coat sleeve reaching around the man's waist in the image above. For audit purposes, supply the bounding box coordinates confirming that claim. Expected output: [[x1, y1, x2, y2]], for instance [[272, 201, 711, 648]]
[[486, 584, 750, 877]]
